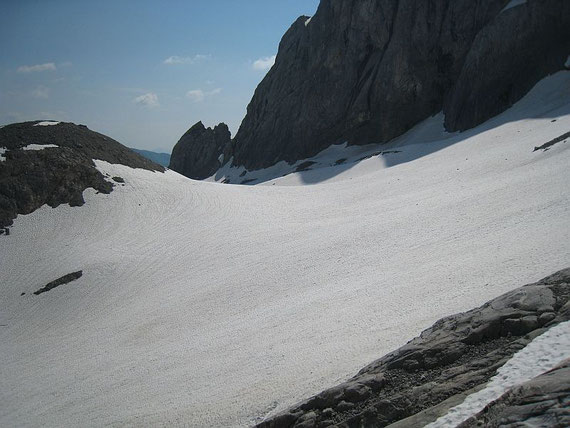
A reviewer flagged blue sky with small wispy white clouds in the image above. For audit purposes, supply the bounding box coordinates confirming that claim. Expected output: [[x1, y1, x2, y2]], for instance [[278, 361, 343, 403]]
[[0, 0, 319, 153]]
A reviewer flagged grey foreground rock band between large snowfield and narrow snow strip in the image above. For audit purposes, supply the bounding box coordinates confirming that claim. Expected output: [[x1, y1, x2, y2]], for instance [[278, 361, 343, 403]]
[[258, 268, 570, 428]]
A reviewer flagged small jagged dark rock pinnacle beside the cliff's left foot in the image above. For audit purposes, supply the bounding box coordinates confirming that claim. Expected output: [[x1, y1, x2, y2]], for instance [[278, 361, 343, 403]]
[[169, 122, 232, 180]]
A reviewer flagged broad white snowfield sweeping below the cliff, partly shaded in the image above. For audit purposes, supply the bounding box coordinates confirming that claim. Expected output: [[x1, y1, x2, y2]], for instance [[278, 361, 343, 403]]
[[0, 72, 570, 426]]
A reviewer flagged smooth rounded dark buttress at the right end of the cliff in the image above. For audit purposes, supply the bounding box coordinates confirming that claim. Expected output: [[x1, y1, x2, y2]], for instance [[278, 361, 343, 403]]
[[445, 0, 570, 131]]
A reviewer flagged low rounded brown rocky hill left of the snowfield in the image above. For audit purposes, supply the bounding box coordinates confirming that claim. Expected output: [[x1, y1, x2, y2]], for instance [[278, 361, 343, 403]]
[[0, 121, 164, 227]]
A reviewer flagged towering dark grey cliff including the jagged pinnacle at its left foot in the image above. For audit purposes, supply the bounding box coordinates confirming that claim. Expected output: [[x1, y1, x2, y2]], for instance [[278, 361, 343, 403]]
[[171, 0, 570, 178]]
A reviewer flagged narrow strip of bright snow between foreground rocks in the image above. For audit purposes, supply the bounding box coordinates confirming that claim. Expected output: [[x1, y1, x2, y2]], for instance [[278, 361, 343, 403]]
[[426, 321, 570, 428]]
